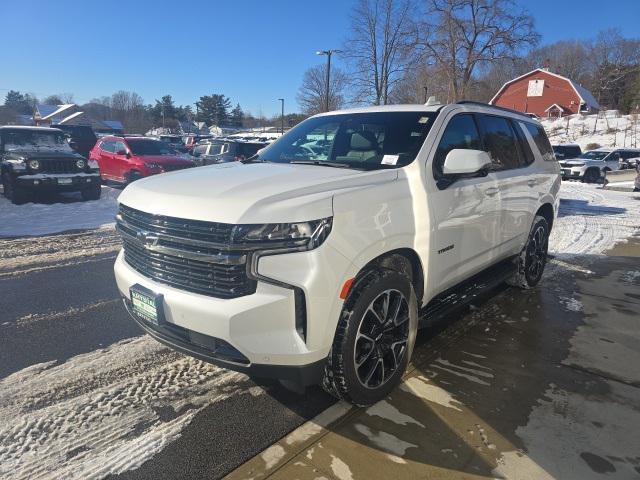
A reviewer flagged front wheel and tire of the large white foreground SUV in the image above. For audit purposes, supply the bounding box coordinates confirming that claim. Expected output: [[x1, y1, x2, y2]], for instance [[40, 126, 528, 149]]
[[322, 268, 418, 406]]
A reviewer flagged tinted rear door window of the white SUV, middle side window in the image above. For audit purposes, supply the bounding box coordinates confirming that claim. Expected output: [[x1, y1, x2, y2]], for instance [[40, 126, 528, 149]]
[[481, 115, 520, 170]]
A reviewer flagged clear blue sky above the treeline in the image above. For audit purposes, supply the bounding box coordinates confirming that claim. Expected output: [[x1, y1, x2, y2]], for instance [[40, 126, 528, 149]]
[[0, 0, 640, 116]]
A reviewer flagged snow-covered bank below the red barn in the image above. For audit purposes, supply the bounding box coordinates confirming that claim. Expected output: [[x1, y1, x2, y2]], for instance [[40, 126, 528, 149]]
[[541, 111, 640, 151]]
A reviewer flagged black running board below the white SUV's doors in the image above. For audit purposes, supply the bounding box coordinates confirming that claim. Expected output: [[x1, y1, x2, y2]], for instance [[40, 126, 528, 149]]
[[418, 257, 516, 328]]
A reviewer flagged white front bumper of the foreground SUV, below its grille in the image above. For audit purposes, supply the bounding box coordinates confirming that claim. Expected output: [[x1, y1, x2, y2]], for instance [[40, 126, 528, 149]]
[[114, 245, 350, 385]]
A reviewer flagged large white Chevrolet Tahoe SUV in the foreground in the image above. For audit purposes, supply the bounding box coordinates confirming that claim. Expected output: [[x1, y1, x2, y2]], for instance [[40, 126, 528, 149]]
[[115, 102, 560, 405]]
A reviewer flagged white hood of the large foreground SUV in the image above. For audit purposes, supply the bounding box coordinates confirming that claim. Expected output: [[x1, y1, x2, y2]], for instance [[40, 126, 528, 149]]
[[119, 162, 398, 224]]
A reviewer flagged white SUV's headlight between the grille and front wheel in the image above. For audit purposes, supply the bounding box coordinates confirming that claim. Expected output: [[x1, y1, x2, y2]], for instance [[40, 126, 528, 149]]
[[232, 217, 333, 250]]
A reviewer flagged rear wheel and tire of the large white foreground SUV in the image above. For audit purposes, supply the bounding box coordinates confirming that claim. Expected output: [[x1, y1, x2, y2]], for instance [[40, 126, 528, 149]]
[[507, 215, 550, 289]]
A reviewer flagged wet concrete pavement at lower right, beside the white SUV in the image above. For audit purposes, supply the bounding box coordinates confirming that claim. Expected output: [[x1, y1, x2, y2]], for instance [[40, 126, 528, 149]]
[[228, 237, 640, 480]]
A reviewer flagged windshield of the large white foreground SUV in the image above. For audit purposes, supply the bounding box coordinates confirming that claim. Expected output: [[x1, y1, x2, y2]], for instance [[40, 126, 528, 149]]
[[260, 112, 437, 170]]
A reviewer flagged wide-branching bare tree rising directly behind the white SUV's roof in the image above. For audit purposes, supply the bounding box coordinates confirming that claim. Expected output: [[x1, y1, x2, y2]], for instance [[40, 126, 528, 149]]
[[416, 0, 540, 101]]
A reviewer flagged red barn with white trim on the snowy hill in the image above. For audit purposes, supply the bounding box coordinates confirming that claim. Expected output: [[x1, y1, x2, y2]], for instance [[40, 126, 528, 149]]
[[489, 68, 600, 117]]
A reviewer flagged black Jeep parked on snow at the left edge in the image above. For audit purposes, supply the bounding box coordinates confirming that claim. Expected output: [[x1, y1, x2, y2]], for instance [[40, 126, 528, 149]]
[[0, 126, 101, 204]]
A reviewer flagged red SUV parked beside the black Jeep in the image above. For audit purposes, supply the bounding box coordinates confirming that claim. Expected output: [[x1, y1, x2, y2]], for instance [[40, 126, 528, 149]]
[[89, 136, 195, 183]]
